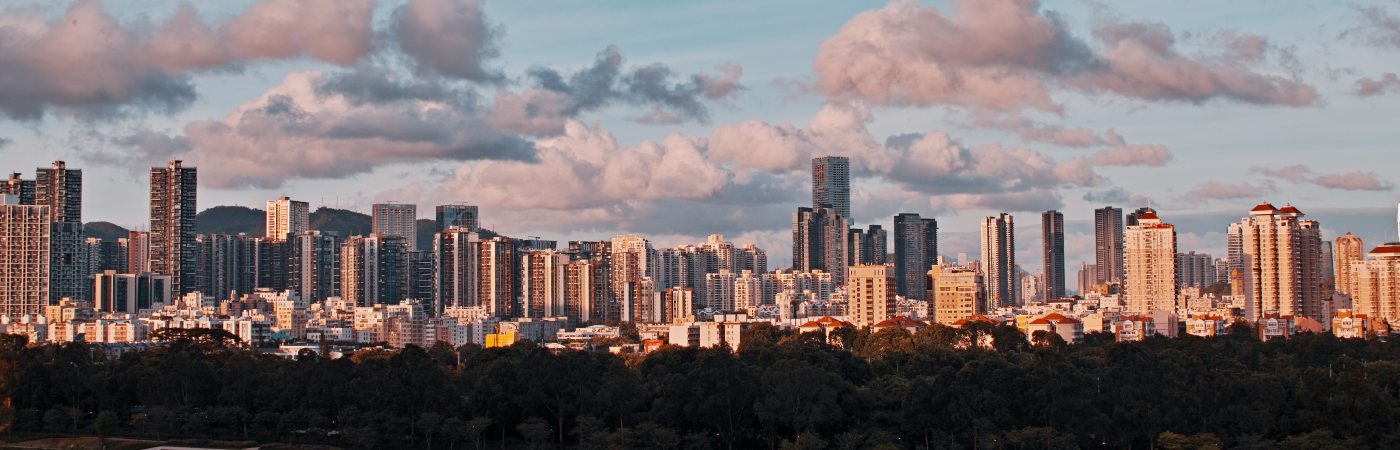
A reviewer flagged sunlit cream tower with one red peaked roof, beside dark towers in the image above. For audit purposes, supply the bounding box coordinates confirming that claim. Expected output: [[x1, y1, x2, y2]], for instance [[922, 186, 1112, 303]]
[[1123, 209, 1176, 313]]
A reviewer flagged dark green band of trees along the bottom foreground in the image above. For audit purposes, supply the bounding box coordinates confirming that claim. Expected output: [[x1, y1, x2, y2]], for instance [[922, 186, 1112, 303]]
[[0, 322, 1400, 449]]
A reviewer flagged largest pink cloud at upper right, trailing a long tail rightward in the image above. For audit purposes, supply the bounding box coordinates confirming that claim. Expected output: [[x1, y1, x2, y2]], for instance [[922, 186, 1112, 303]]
[[813, 0, 1317, 113]]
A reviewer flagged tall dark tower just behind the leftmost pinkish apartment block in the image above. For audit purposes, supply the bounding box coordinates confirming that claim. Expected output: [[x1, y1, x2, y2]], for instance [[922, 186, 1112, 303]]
[[34, 161, 84, 304]]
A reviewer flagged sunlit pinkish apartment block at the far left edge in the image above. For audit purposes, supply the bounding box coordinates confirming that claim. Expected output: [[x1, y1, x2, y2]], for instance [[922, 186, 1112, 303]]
[[0, 193, 53, 318]]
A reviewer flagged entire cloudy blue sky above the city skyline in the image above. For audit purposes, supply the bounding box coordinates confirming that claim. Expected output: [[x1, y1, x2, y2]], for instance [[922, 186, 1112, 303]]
[[0, 0, 1400, 285]]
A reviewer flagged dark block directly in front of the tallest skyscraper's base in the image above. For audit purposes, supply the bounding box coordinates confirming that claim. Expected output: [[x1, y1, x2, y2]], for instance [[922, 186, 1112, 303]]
[[792, 207, 850, 283]]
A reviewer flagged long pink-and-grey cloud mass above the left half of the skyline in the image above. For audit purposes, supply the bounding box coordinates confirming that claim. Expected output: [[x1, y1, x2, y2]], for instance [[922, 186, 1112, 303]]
[[107, 71, 535, 188]]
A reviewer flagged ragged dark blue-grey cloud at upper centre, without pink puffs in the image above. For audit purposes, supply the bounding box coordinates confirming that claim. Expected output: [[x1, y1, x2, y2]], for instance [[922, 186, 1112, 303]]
[[523, 46, 743, 123]]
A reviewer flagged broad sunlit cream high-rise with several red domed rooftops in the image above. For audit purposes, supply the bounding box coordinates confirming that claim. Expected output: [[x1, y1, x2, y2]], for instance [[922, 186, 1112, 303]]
[[1239, 203, 1330, 321]]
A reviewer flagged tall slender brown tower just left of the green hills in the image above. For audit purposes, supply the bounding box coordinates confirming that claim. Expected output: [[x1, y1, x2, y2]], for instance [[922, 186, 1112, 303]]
[[150, 160, 199, 297]]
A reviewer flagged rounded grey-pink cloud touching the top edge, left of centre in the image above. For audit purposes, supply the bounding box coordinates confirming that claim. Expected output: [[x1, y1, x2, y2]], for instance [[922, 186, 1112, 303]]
[[392, 0, 504, 83]]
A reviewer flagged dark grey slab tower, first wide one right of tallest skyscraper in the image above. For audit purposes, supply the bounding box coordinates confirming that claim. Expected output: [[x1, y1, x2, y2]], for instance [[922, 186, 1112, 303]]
[[893, 213, 938, 300]]
